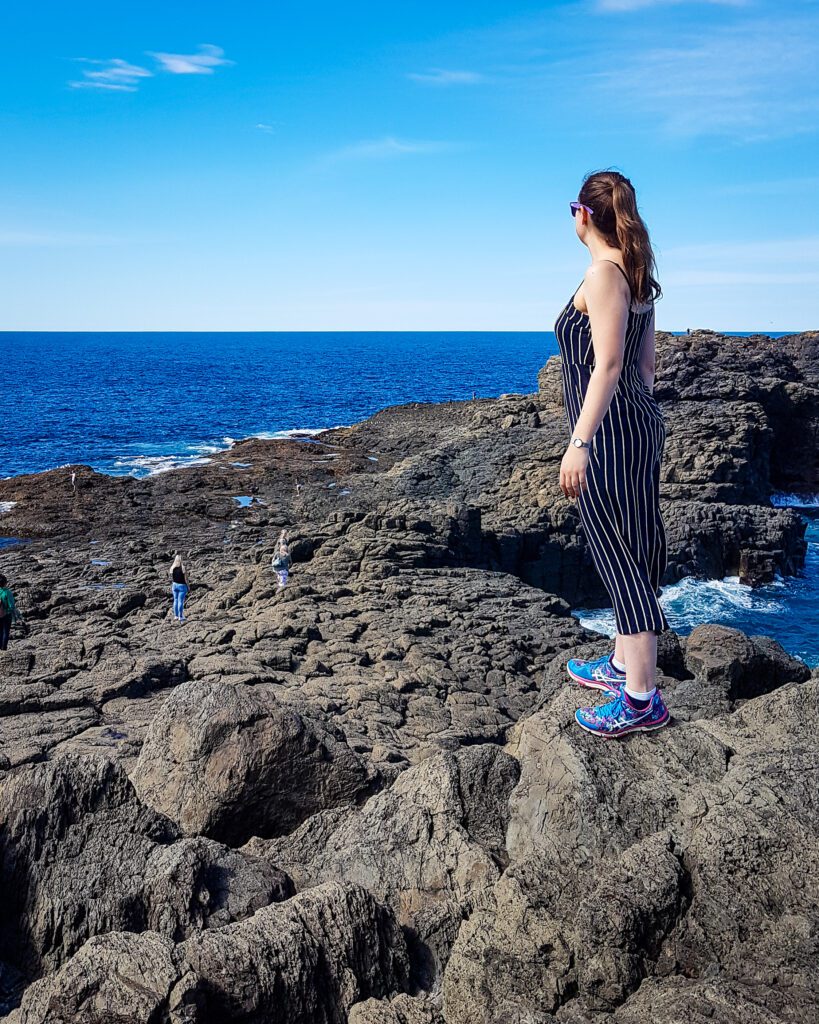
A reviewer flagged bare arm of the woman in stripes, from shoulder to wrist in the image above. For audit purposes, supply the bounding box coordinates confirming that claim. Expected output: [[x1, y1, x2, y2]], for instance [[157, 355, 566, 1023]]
[[574, 262, 629, 441]]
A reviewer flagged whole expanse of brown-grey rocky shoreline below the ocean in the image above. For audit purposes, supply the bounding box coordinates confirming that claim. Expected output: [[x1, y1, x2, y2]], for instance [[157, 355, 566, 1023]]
[[0, 331, 819, 1024]]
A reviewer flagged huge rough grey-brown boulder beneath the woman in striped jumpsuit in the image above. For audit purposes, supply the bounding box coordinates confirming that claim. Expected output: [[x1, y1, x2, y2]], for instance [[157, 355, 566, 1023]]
[[443, 675, 819, 1024]]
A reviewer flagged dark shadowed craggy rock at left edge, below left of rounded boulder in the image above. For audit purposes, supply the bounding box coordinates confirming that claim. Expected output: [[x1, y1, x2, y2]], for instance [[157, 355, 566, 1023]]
[[0, 757, 293, 978]]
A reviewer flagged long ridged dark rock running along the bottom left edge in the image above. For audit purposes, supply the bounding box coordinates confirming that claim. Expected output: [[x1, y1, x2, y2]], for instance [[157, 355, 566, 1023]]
[[8, 884, 407, 1024]]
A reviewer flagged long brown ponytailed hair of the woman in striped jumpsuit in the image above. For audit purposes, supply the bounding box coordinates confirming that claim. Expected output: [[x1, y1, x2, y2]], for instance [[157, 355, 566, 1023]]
[[577, 171, 662, 303]]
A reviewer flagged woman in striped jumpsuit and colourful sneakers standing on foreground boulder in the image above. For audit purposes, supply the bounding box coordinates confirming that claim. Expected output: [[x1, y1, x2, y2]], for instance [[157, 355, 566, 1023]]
[[555, 171, 670, 737]]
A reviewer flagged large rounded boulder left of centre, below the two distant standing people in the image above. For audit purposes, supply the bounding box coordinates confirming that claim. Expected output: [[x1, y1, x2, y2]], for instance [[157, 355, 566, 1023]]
[[133, 683, 377, 845]]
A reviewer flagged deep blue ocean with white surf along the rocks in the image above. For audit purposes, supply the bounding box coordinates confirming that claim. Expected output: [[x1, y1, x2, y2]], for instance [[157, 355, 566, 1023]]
[[0, 332, 819, 666]]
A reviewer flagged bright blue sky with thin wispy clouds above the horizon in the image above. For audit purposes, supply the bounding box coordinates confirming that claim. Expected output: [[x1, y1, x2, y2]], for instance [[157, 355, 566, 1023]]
[[0, 0, 819, 331]]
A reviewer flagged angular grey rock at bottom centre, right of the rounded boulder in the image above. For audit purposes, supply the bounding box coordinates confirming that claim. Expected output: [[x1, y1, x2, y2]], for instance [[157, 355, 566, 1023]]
[[246, 746, 518, 985]]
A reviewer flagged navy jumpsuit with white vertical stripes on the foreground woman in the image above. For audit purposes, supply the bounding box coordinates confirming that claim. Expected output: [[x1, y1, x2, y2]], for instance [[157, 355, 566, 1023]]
[[555, 260, 669, 633]]
